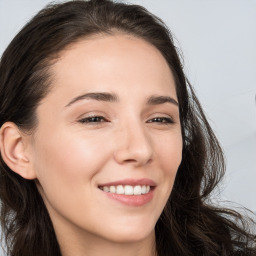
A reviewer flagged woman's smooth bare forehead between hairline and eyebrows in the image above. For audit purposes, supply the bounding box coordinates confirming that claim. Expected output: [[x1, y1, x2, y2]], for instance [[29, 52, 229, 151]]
[[44, 34, 176, 104]]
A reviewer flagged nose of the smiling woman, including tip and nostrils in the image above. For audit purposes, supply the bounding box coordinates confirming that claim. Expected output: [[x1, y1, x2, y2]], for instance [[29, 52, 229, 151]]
[[114, 122, 153, 167]]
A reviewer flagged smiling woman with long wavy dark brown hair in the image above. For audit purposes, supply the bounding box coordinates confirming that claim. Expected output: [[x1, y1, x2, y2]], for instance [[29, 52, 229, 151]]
[[0, 0, 256, 256]]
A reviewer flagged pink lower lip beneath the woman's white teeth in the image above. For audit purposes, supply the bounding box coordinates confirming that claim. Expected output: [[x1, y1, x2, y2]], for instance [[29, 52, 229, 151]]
[[102, 189, 154, 206]]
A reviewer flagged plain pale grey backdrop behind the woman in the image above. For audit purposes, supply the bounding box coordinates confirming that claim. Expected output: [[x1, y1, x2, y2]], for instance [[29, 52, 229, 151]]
[[0, 0, 256, 254]]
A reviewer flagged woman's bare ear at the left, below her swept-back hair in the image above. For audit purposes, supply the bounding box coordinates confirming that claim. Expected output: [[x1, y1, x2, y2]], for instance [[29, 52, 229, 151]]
[[0, 122, 36, 180]]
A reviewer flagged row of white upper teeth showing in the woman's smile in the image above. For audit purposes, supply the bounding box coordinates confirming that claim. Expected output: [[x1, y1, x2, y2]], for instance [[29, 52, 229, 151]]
[[100, 185, 150, 195]]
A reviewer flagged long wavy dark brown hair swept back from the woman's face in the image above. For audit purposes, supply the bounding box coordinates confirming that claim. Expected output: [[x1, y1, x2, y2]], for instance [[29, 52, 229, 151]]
[[0, 0, 256, 256]]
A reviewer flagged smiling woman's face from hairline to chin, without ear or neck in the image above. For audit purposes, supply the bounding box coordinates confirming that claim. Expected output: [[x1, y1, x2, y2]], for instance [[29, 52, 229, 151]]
[[31, 34, 182, 242]]
